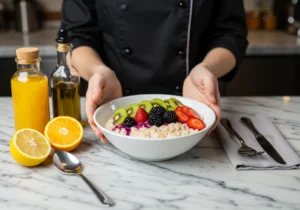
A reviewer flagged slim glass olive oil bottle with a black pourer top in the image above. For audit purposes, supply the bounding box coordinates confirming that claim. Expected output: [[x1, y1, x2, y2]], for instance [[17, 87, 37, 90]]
[[51, 29, 81, 120]]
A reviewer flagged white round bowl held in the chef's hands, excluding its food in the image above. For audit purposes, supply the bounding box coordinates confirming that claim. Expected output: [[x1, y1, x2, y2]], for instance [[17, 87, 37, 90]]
[[94, 94, 216, 161]]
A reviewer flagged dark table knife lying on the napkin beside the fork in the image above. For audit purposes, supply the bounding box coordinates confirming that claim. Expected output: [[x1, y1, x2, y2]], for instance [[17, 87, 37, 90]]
[[241, 117, 286, 164]]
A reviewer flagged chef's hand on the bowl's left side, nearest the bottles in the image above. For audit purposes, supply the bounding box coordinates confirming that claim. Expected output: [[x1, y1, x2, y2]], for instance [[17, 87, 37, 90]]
[[86, 69, 122, 143]]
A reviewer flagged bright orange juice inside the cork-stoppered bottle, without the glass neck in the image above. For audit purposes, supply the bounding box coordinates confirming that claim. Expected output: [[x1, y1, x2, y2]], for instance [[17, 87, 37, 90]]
[[11, 75, 50, 133]]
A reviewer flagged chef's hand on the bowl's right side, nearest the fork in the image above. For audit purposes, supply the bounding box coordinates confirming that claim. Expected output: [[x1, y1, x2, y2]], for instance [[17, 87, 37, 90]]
[[183, 64, 221, 135]]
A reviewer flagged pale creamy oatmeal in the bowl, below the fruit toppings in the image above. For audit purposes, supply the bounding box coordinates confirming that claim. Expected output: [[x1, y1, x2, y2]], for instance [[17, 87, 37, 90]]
[[105, 118, 197, 138]]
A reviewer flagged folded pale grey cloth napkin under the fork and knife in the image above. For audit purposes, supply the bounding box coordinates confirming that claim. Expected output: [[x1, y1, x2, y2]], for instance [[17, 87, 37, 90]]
[[216, 113, 300, 170]]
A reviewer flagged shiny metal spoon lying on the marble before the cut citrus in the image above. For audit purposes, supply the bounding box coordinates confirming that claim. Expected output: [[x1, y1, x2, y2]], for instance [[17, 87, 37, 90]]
[[53, 151, 115, 206]]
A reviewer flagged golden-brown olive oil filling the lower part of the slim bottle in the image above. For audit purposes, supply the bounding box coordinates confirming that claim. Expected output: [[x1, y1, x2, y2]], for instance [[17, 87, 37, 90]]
[[52, 81, 81, 120]]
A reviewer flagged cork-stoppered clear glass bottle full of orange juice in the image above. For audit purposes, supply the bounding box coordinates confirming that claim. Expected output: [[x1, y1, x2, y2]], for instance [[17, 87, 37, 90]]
[[11, 47, 50, 133]]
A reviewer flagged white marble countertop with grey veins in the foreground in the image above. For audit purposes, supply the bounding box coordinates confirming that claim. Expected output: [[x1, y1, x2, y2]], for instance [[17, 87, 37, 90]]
[[0, 97, 300, 210]]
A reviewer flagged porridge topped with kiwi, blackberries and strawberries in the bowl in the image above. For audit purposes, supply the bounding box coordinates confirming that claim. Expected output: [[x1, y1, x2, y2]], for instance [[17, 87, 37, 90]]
[[104, 98, 205, 138]]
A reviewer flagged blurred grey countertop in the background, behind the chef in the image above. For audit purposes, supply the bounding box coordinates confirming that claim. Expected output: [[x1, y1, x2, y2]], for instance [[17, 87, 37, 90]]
[[0, 28, 300, 58]]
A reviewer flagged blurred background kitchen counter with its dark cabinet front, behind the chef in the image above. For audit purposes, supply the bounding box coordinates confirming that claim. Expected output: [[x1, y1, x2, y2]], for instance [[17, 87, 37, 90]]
[[0, 28, 300, 96]]
